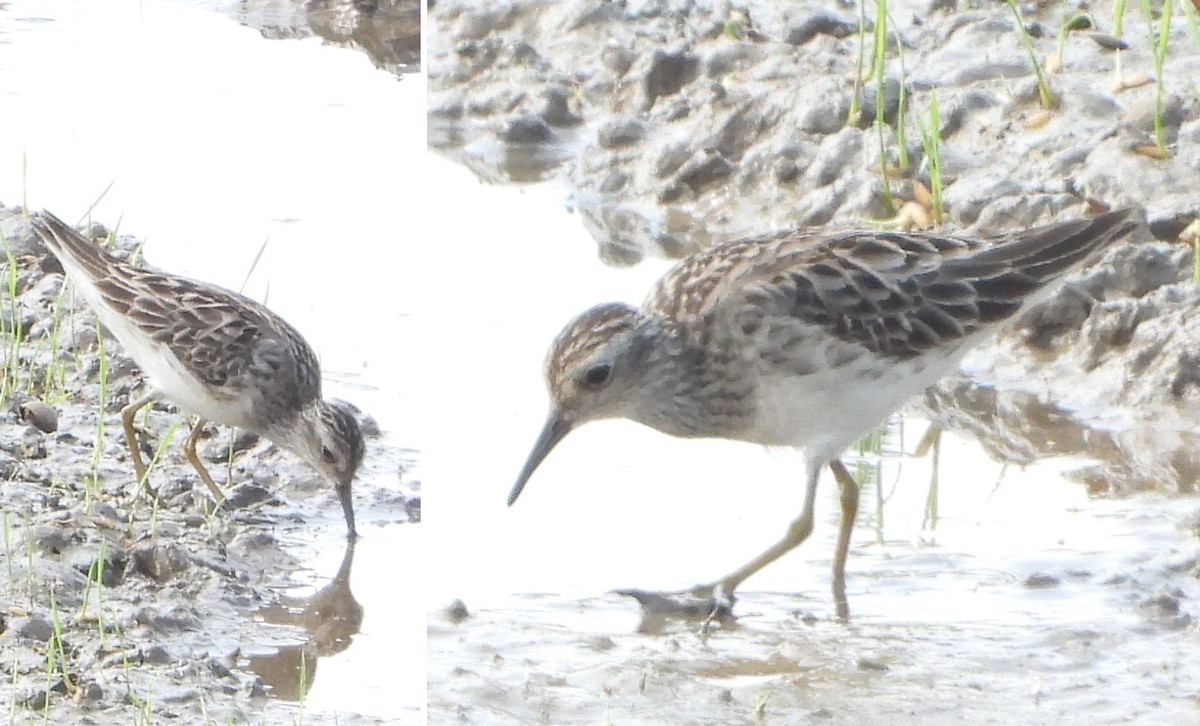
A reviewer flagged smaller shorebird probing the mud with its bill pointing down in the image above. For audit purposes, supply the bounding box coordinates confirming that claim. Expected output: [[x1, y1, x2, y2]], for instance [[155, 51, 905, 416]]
[[32, 211, 364, 538]]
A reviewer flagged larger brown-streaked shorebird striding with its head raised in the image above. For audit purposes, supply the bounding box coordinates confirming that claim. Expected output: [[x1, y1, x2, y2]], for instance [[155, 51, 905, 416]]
[[509, 209, 1138, 619]]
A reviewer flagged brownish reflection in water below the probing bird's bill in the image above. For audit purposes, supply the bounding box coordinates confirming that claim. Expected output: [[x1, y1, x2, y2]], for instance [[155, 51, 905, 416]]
[[247, 540, 362, 701]]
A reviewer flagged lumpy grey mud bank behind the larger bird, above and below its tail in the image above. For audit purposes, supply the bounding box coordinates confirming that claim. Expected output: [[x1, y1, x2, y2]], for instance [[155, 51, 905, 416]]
[[428, 1, 1200, 492]]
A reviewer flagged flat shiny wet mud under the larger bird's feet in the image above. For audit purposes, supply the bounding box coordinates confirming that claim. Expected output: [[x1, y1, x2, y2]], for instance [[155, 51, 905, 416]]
[[428, 472, 1200, 725]]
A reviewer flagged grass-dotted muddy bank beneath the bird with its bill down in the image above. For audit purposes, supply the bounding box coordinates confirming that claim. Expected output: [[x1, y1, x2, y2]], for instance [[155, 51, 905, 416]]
[[0, 209, 420, 724]]
